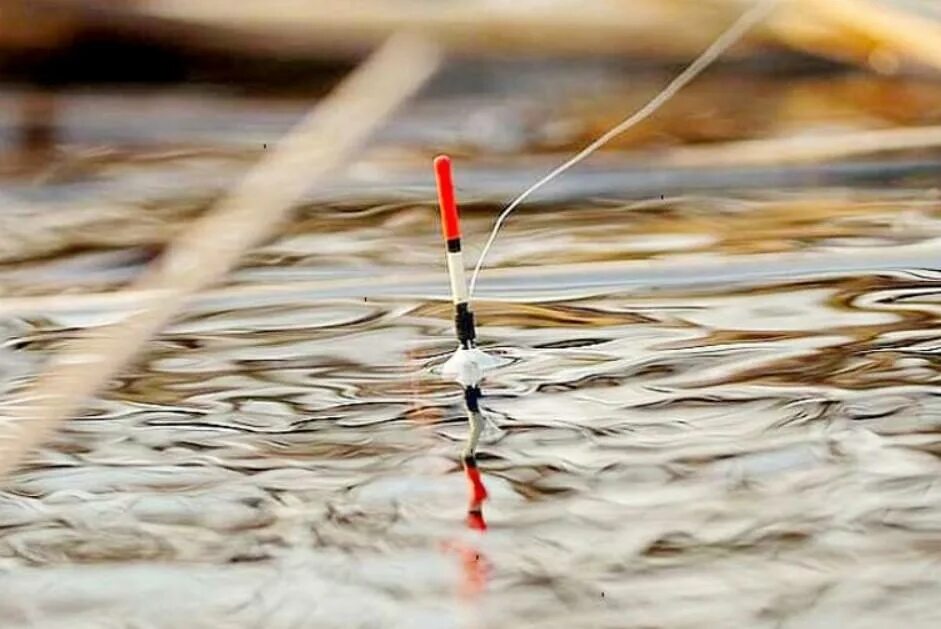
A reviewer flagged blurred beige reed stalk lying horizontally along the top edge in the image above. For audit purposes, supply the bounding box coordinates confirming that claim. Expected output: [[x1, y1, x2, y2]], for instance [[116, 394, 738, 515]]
[[139, 0, 740, 59]]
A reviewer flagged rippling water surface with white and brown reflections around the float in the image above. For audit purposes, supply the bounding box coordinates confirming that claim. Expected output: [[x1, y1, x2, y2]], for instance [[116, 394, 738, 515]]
[[0, 71, 941, 628]]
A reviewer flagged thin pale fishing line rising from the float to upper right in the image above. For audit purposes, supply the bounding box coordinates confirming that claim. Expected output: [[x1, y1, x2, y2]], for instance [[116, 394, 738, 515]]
[[467, 0, 779, 297]]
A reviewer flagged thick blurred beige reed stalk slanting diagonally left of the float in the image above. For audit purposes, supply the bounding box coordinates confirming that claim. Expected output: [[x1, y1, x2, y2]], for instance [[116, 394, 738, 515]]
[[0, 35, 439, 478]]
